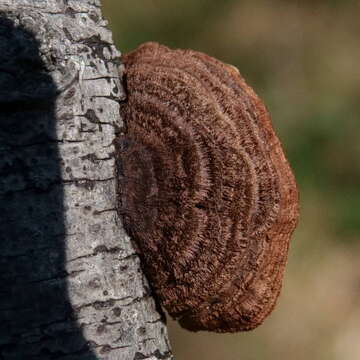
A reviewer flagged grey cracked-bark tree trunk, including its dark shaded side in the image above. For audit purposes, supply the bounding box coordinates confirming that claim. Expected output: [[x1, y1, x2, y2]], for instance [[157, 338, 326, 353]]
[[0, 0, 171, 360]]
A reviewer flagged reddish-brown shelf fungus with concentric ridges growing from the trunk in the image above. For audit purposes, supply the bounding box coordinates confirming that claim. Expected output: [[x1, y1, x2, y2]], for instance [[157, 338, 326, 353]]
[[117, 43, 298, 332]]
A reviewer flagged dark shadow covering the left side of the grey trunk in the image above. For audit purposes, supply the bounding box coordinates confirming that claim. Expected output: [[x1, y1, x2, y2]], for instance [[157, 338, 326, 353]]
[[0, 14, 97, 360]]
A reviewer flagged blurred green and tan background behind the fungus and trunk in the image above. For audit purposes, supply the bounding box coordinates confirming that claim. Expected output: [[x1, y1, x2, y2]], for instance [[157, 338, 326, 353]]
[[103, 0, 360, 360]]
